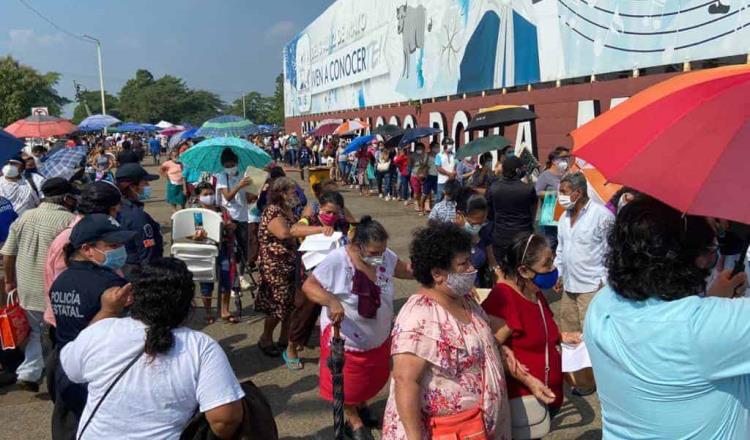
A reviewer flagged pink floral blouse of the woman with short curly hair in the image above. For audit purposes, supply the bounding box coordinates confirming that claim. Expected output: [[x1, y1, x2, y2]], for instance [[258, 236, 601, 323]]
[[382, 294, 511, 440]]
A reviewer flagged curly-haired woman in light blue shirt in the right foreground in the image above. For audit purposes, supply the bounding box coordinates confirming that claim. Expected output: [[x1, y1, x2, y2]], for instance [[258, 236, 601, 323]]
[[584, 197, 750, 440]]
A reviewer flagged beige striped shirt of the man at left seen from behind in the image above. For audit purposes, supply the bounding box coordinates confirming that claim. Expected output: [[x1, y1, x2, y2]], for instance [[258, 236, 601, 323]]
[[0, 202, 75, 312]]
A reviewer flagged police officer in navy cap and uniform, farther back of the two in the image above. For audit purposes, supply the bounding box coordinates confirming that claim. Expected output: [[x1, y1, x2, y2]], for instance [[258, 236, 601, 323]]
[[115, 163, 164, 278]]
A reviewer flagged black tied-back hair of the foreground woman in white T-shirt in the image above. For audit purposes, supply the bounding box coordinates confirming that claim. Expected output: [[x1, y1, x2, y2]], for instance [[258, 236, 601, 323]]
[[130, 258, 195, 358]]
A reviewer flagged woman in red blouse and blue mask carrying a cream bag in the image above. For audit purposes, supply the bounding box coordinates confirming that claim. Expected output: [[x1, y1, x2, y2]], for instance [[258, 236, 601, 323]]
[[482, 234, 580, 440]]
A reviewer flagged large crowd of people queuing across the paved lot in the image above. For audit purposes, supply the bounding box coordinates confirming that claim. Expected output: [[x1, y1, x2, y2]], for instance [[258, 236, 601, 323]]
[[0, 128, 750, 440]]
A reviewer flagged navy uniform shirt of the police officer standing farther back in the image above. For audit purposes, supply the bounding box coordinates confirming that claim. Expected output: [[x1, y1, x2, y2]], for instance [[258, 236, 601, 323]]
[[117, 199, 164, 265]]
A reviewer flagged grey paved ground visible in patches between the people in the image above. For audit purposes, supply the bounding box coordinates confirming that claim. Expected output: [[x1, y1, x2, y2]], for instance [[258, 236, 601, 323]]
[[0, 166, 601, 440]]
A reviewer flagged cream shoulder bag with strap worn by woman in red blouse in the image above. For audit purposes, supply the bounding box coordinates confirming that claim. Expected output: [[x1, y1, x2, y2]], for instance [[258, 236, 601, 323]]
[[510, 298, 551, 440]]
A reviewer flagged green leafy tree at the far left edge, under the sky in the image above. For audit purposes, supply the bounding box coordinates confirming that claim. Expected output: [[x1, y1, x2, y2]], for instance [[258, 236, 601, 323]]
[[0, 56, 70, 127]]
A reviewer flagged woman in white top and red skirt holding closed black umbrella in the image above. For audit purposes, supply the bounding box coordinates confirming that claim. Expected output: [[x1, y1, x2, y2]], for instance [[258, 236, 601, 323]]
[[302, 216, 413, 440]]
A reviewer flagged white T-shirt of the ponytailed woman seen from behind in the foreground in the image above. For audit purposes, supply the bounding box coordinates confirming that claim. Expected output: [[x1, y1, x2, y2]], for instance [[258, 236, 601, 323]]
[[60, 318, 245, 440]]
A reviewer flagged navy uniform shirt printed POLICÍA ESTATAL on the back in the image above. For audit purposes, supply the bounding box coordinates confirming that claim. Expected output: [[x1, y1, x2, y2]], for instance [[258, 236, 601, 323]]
[[49, 261, 127, 346]]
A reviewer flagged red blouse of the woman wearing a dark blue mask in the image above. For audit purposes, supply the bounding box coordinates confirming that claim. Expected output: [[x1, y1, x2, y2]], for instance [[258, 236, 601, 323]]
[[482, 283, 563, 408]]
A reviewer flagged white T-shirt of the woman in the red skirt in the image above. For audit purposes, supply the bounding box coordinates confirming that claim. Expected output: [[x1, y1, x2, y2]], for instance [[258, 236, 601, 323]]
[[313, 247, 398, 351]]
